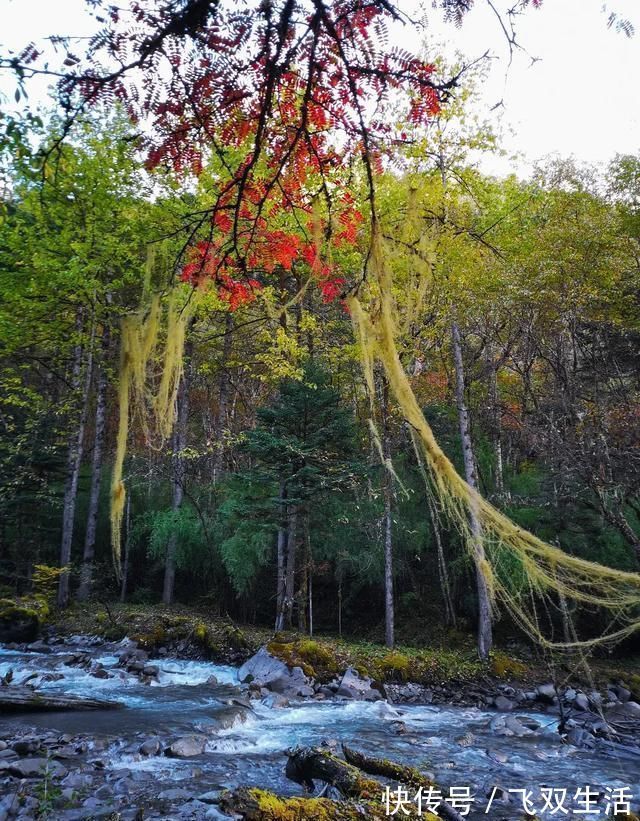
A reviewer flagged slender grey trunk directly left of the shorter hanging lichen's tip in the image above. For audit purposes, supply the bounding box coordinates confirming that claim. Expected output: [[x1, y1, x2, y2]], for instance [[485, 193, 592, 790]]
[[77, 325, 110, 601]]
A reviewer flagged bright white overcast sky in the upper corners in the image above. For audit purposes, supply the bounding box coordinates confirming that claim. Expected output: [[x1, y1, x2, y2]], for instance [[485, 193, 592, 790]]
[[0, 0, 640, 173]]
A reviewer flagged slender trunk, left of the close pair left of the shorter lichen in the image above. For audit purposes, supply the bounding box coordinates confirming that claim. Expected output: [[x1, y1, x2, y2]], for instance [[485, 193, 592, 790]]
[[58, 312, 93, 607]]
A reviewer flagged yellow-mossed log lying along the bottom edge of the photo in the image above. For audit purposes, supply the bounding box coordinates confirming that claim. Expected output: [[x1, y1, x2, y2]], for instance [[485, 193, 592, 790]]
[[220, 782, 438, 821]]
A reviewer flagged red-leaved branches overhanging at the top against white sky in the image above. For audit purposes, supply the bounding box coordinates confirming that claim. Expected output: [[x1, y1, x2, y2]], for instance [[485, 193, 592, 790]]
[[60, 0, 538, 308]]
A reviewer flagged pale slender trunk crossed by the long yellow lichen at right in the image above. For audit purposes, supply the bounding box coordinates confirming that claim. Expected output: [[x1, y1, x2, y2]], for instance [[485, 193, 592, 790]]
[[451, 322, 493, 659]]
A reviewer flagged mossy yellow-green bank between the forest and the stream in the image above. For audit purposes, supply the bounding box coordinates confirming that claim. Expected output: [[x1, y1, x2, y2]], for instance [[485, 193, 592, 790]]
[[49, 601, 640, 700]]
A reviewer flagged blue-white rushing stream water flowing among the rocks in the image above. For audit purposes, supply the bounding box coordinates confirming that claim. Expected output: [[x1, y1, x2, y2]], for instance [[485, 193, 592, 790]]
[[0, 645, 640, 819]]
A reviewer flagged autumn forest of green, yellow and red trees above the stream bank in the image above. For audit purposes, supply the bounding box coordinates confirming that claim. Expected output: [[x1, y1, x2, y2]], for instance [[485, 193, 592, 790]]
[[0, 0, 640, 658]]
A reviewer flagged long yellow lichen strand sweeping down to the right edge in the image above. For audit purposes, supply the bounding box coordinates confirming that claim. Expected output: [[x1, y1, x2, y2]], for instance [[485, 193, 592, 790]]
[[348, 231, 640, 649]]
